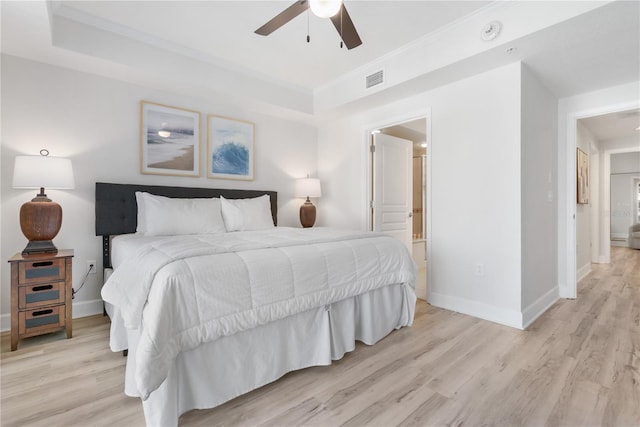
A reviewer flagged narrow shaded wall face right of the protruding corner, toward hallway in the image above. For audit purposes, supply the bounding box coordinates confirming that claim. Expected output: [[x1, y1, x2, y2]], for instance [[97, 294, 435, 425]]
[[521, 66, 558, 326]]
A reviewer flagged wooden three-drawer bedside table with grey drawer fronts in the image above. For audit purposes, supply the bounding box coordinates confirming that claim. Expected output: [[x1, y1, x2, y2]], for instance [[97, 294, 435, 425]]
[[9, 250, 73, 351]]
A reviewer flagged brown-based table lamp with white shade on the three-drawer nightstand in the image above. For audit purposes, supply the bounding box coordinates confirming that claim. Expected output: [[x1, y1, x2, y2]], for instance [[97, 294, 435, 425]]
[[13, 150, 75, 255]]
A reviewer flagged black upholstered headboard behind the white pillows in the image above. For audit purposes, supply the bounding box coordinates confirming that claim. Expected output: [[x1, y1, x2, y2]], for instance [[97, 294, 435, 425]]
[[96, 182, 278, 268]]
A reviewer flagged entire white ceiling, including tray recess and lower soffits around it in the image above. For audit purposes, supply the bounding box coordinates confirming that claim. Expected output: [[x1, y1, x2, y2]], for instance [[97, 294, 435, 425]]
[[0, 0, 640, 120]]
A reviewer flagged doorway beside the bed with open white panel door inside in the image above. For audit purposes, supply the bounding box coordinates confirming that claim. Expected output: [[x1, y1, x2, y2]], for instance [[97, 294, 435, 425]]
[[368, 117, 429, 300]]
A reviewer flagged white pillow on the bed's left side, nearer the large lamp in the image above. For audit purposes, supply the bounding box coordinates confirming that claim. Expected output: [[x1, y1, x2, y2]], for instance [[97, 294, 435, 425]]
[[136, 193, 225, 236]]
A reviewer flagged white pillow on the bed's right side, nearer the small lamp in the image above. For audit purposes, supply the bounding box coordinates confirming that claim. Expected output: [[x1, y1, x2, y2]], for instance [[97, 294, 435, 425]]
[[220, 194, 274, 231]]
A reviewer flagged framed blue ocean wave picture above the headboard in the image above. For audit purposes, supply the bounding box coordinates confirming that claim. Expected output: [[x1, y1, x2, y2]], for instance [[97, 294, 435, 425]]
[[207, 115, 255, 181]]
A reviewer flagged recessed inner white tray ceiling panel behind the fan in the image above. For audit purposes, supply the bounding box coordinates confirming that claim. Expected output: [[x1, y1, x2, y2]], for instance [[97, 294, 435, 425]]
[[53, 0, 490, 90]]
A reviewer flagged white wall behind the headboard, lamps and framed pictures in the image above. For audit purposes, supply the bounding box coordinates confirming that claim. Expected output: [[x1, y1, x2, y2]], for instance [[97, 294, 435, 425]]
[[0, 55, 322, 330]]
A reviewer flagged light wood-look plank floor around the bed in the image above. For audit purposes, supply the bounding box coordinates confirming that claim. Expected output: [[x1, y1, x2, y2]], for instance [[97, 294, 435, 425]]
[[1, 248, 640, 427]]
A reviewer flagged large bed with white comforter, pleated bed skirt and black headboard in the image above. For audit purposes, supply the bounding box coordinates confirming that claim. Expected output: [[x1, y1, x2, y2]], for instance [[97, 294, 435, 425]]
[[95, 183, 417, 426]]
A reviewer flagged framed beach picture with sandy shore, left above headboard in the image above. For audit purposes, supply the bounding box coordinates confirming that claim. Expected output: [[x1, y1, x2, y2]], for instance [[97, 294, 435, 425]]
[[140, 101, 200, 176]]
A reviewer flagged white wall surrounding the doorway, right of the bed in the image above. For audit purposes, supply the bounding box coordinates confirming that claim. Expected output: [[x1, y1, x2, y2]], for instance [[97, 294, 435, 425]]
[[318, 63, 522, 327]]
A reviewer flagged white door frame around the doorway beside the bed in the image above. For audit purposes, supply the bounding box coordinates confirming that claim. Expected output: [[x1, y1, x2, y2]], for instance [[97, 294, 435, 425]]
[[361, 107, 434, 301]]
